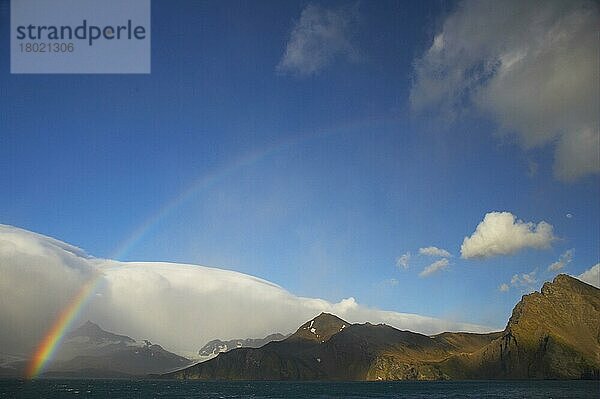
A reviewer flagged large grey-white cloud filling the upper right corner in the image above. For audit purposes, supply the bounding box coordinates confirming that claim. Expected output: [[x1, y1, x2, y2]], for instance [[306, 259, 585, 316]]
[[410, 0, 600, 181]]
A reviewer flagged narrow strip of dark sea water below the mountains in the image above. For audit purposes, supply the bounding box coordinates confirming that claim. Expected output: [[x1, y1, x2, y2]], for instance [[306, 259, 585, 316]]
[[0, 379, 600, 399]]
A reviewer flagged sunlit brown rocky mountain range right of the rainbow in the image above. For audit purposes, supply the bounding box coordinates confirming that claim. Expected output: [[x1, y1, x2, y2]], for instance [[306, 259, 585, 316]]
[[164, 275, 600, 381]]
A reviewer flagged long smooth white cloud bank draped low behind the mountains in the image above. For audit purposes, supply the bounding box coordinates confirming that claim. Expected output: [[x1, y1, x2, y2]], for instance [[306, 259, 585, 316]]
[[0, 225, 489, 356]]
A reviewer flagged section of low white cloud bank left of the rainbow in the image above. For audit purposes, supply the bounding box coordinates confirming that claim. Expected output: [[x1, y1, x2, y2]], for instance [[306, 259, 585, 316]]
[[0, 225, 94, 355]]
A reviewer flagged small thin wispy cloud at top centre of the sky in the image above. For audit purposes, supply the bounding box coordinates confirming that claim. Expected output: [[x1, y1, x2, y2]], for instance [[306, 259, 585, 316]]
[[277, 4, 358, 76]]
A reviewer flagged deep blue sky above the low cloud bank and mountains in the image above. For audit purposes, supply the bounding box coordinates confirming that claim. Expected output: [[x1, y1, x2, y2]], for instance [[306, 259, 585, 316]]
[[0, 0, 600, 327]]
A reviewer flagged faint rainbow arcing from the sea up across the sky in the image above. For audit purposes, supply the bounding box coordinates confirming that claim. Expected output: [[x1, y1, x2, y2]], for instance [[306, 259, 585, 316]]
[[26, 118, 382, 379]]
